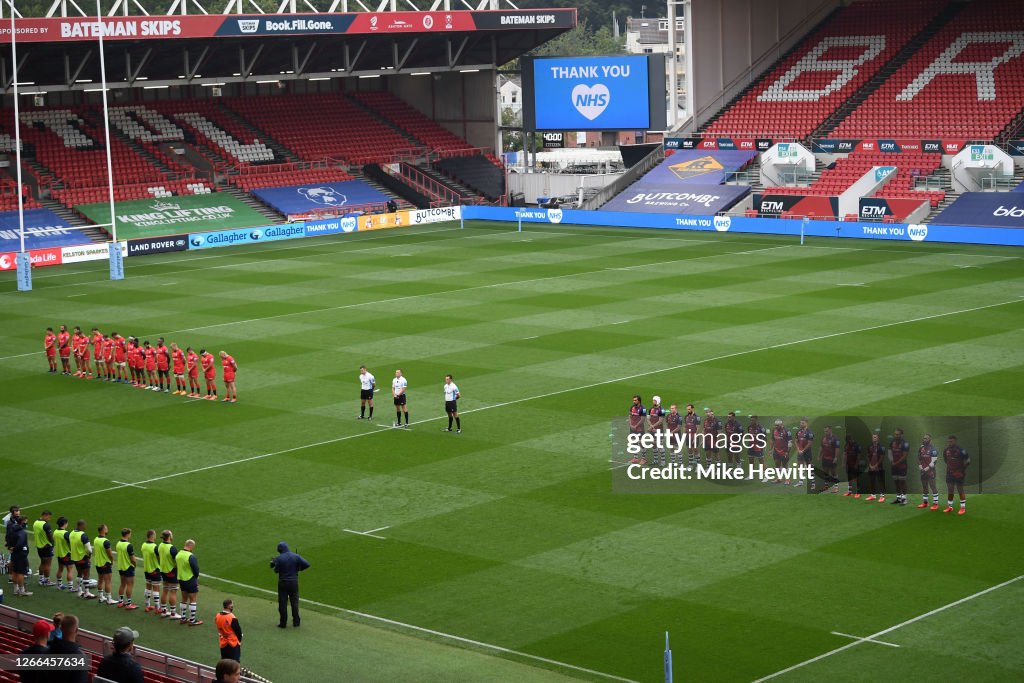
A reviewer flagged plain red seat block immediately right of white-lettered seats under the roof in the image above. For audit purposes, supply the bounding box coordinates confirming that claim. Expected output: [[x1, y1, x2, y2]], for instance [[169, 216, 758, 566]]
[[230, 93, 417, 166]]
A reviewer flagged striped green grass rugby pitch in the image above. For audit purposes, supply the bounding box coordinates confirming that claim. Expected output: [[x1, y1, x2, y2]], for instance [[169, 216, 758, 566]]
[[0, 223, 1024, 683]]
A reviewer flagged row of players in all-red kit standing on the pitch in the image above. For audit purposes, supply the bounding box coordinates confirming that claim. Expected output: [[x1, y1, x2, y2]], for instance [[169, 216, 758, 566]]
[[43, 325, 238, 403]]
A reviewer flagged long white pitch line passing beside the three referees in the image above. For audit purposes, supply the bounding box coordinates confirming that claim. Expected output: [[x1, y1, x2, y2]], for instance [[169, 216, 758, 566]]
[[23, 299, 1020, 510]]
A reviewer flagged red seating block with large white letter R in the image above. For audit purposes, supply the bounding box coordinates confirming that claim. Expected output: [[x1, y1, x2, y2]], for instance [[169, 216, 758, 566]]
[[830, 0, 1024, 140]]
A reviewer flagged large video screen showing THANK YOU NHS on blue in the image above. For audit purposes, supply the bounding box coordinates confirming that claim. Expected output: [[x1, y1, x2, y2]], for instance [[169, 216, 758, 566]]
[[523, 55, 665, 130]]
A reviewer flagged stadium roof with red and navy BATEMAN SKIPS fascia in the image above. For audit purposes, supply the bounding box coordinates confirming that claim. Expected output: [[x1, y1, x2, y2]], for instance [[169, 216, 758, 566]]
[[0, 1, 577, 94]]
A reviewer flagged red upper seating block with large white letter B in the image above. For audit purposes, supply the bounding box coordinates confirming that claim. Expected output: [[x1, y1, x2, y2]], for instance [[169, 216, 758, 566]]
[[706, 0, 942, 138]]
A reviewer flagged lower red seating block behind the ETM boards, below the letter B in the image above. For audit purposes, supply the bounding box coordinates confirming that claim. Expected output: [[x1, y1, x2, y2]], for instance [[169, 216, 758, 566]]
[[765, 152, 946, 208]]
